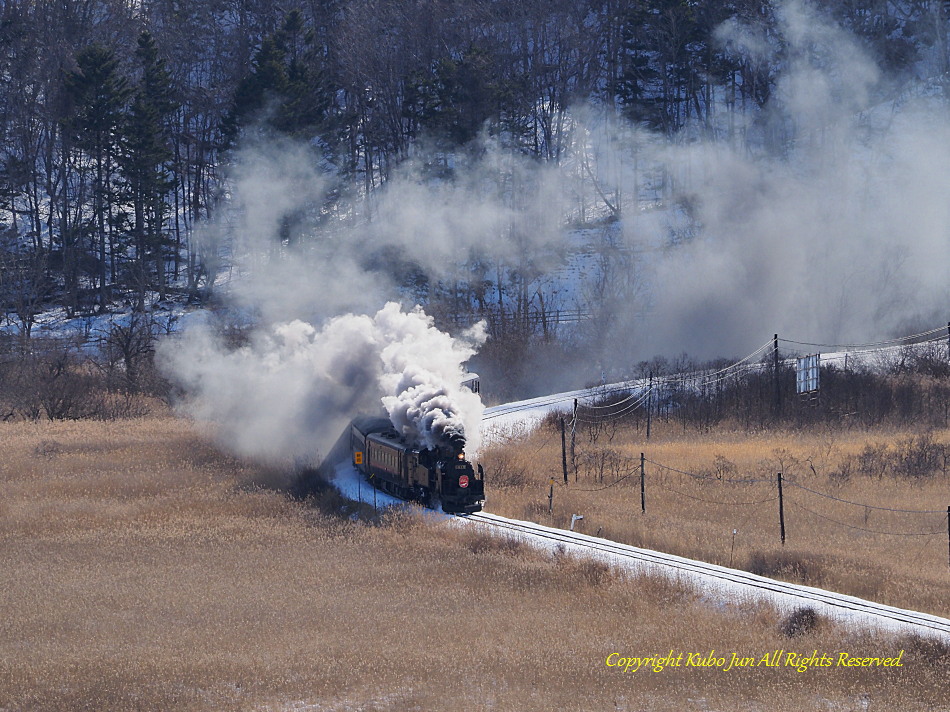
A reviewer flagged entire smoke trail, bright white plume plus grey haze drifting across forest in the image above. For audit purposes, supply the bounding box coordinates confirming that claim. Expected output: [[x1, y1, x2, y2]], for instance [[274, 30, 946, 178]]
[[163, 2, 950, 444]]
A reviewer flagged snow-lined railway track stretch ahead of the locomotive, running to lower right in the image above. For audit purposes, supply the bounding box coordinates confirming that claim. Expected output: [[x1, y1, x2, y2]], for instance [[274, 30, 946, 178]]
[[458, 512, 950, 642]]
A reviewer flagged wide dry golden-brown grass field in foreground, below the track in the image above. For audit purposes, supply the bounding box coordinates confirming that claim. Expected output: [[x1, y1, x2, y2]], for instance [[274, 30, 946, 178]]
[[0, 417, 950, 712]]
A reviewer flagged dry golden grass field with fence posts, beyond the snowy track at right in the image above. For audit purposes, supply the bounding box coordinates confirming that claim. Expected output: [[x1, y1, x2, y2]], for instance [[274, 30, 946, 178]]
[[482, 422, 950, 616]]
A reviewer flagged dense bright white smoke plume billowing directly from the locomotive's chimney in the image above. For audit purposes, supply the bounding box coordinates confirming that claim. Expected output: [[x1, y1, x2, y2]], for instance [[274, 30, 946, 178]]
[[160, 302, 484, 461]]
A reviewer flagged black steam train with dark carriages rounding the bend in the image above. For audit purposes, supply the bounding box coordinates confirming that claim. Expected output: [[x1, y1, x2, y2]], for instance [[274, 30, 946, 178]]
[[350, 417, 485, 514]]
